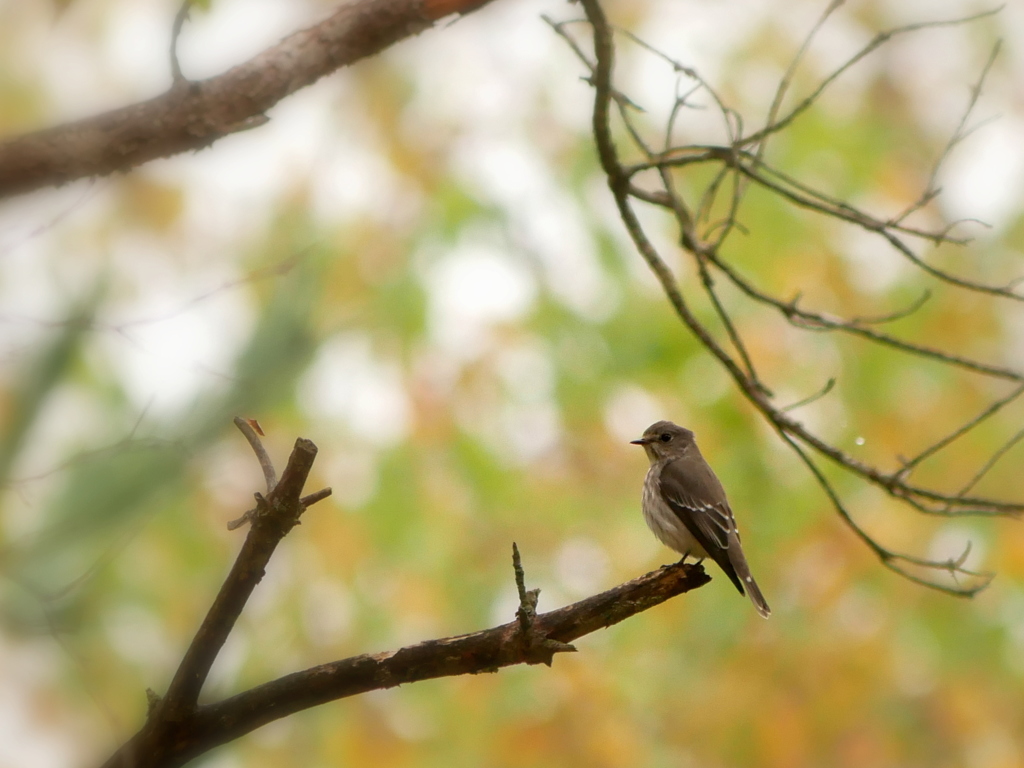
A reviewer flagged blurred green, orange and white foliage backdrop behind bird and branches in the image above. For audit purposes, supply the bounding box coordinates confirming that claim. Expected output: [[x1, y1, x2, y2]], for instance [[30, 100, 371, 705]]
[[0, 0, 1024, 768]]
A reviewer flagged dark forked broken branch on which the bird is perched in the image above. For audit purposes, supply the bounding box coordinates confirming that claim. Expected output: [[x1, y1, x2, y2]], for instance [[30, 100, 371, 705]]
[[103, 428, 711, 768]]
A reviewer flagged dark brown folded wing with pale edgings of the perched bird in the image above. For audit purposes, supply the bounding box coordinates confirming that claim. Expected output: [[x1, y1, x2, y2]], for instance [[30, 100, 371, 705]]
[[659, 462, 745, 594]]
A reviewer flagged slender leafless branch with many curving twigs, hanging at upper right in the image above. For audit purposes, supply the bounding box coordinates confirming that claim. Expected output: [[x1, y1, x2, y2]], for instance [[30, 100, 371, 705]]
[[573, 0, 1024, 595]]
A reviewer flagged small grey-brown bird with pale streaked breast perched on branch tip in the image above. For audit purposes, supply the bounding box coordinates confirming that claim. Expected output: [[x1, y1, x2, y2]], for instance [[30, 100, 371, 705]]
[[632, 421, 771, 618]]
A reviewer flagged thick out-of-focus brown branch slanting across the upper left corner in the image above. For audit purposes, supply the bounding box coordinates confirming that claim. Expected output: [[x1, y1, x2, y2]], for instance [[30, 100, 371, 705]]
[[0, 0, 490, 198]]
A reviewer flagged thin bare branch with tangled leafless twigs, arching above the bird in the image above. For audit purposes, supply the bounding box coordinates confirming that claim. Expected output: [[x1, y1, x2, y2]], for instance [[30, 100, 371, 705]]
[[569, 0, 1024, 596]]
